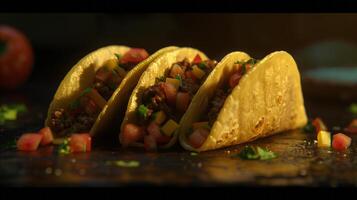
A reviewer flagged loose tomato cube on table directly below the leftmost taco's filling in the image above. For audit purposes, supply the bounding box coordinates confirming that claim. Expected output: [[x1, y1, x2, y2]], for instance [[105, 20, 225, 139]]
[[69, 133, 92, 152]]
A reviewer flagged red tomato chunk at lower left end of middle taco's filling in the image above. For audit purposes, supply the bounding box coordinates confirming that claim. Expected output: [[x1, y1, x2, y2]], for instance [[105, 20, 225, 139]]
[[121, 123, 144, 147]]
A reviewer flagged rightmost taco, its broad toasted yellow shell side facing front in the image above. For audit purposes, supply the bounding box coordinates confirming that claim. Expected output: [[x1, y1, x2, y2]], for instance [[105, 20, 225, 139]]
[[178, 51, 307, 151]]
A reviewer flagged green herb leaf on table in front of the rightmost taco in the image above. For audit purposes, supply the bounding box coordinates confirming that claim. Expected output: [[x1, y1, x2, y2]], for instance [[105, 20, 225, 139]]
[[233, 146, 277, 160]]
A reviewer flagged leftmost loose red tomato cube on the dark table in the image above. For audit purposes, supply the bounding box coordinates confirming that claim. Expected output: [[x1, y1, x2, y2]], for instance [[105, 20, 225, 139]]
[[17, 133, 43, 151]]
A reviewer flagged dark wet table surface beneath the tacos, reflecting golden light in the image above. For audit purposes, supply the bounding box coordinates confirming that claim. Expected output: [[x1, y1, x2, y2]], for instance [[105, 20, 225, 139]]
[[0, 83, 357, 186]]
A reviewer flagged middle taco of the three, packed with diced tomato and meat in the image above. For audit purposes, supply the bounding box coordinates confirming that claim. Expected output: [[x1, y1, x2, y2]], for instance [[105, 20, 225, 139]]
[[119, 48, 217, 150]]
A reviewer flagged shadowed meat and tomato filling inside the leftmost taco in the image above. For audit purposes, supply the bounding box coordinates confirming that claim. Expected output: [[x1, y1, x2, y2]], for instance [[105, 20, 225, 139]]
[[49, 49, 148, 136]]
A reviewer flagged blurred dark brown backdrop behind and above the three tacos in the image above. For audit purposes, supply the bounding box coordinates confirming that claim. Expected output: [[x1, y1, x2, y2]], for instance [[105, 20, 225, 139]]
[[0, 13, 357, 106]]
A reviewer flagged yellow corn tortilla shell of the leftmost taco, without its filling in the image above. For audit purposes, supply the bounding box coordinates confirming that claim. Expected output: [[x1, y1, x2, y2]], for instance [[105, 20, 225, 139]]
[[45, 45, 177, 139]]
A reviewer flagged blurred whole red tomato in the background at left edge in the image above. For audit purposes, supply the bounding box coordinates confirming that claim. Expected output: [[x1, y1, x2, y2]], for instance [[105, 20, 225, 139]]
[[0, 25, 33, 89]]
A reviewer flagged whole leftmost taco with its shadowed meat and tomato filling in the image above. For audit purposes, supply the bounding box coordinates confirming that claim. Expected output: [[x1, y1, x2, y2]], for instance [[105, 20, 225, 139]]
[[45, 46, 176, 138]]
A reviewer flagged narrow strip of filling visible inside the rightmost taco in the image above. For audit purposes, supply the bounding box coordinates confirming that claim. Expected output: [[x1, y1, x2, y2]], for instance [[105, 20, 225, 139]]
[[188, 58, 258, 148]]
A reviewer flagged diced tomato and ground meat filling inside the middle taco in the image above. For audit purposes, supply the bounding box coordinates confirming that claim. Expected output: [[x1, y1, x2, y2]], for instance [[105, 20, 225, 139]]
[[122, 54, 217, 150]]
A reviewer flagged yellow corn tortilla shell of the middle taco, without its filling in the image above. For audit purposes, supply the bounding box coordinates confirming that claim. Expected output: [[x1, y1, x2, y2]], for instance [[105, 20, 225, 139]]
[[119, 47, 208, 148]]
